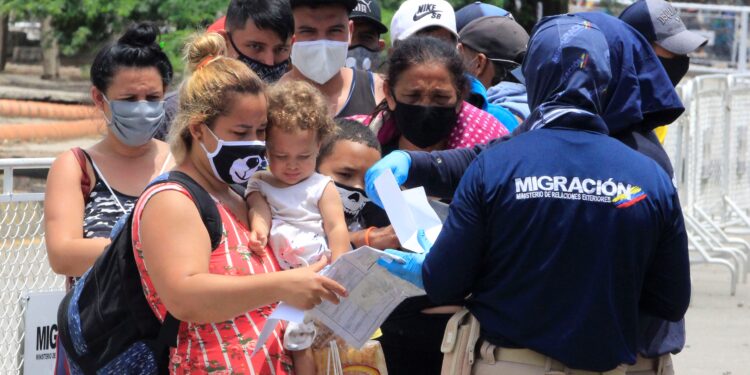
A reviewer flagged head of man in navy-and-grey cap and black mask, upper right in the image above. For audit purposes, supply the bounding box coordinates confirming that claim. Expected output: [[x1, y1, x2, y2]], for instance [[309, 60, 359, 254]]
[[620, 0, 708, 86]]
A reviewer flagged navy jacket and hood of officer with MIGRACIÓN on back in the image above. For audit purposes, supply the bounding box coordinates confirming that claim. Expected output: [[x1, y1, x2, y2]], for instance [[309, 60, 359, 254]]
[[423, 16, 690, 371]]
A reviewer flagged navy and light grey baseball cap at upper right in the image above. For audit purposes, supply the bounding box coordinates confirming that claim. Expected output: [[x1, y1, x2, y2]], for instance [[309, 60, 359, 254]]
[[620, 0, 708, 55]]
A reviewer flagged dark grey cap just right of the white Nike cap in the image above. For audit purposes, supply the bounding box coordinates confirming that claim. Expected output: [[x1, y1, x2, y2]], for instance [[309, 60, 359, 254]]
[[458, 16, 529, 64]]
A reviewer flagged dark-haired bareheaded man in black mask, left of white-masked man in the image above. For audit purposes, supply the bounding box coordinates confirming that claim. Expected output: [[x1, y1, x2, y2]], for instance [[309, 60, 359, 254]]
[[155, 0, 294, 140]]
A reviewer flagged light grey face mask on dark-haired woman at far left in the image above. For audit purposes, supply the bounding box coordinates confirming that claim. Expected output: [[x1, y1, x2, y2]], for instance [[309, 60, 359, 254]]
[[104, 96, 166, 147]]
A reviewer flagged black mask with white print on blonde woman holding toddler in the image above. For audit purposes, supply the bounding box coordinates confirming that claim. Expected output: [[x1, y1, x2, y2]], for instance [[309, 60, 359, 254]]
[[200, 127, 268, 185]]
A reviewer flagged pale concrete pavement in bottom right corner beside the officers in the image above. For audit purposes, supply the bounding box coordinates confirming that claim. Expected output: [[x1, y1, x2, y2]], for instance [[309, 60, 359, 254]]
[[674, 265, 750, 375]]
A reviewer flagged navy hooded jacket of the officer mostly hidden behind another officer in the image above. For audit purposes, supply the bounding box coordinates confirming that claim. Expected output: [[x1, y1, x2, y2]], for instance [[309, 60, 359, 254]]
[[406, 12, 685, 358]]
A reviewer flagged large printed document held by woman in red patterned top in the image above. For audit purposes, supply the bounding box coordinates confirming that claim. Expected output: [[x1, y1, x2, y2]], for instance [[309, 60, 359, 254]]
[[310, 246, 424, 348]]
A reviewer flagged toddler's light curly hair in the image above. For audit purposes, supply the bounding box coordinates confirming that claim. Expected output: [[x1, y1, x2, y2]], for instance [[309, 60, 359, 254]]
[[266, 81, 336, 143]]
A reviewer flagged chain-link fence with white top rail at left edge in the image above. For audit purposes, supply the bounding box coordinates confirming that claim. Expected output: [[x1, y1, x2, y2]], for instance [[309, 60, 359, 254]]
[[0, 159, 65, 375]]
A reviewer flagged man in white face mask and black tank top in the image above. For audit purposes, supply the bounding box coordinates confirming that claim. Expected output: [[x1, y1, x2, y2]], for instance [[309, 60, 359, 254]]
[[282, 0, 383, 117]]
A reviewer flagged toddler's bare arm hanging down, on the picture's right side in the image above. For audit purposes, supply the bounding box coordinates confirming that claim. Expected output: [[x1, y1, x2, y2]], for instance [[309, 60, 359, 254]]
[[318, 182, 350, 261]]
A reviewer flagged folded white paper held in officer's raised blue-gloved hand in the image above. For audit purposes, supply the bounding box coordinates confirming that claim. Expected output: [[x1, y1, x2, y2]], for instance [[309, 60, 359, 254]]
[[375, 170, 443, 253]]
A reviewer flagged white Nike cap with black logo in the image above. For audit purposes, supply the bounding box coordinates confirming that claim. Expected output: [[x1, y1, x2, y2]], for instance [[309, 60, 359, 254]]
[[391, 0, 458, 45]]
